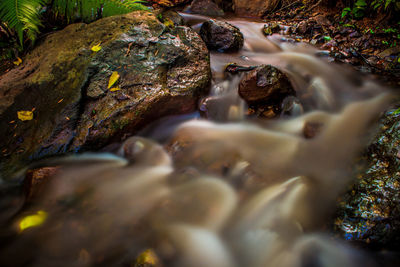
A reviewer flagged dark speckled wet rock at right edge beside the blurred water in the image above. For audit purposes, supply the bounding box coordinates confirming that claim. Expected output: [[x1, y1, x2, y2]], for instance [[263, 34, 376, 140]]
[[335, 109, 400, 249]]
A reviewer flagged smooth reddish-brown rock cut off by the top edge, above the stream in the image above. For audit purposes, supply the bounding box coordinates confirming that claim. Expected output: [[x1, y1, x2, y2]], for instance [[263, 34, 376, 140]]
[[233, 0, 280, 17]]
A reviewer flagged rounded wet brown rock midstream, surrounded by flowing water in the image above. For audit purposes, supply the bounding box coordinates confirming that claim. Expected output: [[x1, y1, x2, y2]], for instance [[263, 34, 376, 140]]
[[239, 65, 294, 104]]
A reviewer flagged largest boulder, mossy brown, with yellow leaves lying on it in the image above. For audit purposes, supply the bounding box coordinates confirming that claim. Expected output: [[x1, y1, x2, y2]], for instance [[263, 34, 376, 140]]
[[0, 12, 211, 177]]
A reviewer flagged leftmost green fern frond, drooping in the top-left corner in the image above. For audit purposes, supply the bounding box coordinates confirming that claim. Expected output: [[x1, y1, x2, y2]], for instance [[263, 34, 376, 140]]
[[0, 0, 46, 46]]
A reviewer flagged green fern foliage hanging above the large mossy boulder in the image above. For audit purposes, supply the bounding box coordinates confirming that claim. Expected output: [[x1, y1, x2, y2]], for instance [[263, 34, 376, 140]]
[[0, 0, 148, 46]]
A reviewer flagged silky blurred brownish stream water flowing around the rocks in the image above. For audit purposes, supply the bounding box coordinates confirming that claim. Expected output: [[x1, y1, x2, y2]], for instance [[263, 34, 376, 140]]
[[0, 14, 393, 267]]
